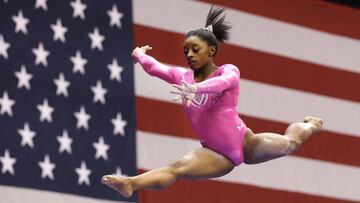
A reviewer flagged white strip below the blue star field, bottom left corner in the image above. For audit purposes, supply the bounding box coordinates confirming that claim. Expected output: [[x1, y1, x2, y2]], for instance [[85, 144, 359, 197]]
[[0, 185, 133, 203]]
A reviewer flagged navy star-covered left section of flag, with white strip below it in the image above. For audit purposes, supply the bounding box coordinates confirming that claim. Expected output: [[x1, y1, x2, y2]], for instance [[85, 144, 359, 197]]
[[0, 0, 136, 203]]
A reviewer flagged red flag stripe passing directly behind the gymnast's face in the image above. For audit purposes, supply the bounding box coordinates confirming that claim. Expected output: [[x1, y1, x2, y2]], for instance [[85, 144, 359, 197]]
[[135, 25, 360, 102]]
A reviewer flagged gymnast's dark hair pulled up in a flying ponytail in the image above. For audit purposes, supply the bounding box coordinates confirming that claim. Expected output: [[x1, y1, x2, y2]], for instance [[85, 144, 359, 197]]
[[185, 5, 231, 53]]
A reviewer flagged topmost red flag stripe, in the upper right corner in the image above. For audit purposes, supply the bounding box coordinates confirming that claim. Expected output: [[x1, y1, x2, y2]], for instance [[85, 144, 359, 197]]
[[198, 0, 360, 39]]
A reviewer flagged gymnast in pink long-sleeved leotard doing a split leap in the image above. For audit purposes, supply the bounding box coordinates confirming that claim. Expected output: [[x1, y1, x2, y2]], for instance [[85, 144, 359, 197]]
[[101, 7, 323, 197]]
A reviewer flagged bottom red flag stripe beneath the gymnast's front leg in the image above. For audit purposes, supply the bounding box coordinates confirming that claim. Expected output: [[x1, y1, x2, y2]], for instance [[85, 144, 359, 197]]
[[139, 170, 358, 203]]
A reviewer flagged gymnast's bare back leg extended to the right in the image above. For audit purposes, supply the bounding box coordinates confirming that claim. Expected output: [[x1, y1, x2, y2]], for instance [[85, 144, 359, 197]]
[[244, 116, 323, 164]]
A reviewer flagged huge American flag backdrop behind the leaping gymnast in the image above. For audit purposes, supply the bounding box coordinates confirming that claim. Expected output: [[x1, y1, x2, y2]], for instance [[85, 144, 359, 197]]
[[0, 0, 360, 203]]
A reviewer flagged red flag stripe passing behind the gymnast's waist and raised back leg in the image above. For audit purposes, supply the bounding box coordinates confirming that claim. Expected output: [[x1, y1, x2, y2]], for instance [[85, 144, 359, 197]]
[[136, 96, 360, 166]]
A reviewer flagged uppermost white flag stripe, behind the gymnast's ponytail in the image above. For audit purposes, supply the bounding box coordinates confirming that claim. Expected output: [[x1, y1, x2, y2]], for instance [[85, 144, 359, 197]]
[[133, 0, 360, 73]]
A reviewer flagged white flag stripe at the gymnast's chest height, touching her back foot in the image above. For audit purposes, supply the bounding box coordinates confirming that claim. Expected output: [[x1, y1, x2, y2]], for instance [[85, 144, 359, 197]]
[[134, 64, 360, 137]]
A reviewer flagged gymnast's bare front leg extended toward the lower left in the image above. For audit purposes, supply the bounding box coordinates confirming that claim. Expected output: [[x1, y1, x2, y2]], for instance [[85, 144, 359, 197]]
[[101, 148, 234, 197]]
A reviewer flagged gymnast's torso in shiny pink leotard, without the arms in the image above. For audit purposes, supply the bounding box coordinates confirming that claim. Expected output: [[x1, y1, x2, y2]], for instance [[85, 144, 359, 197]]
[[182, 65, 246, 151]]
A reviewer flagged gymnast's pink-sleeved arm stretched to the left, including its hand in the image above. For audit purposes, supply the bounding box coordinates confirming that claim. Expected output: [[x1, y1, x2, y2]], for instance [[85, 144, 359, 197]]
[[132, 45, 186, 84]]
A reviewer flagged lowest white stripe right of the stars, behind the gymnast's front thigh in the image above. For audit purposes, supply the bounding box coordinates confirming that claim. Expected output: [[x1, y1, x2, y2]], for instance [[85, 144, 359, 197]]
[[137, 131, 360, 201]]
